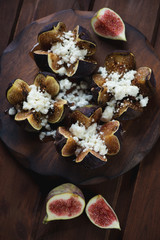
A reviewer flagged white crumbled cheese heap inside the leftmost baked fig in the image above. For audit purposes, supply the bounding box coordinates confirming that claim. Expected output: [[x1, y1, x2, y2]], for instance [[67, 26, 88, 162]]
[[22, 85, 54, 114]]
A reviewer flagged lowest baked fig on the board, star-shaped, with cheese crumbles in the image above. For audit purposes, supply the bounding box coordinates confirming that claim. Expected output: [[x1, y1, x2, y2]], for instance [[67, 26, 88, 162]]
[[55, 107, 120, 169]]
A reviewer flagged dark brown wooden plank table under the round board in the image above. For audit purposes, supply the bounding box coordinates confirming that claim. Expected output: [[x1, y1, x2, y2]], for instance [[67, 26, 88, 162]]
[[0, 0, 160, 240]]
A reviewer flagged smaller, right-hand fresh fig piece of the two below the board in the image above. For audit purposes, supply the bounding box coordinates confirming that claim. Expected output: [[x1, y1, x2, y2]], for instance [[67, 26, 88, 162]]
[[86, 195, 120, 229]]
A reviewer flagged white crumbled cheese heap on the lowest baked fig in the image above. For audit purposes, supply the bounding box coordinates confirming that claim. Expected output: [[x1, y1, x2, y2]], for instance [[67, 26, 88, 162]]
[[69, 122, 108, 155]]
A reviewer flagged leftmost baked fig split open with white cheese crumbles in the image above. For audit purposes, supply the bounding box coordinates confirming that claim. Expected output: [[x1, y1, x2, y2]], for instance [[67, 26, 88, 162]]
[[7, 72, 67, 130]]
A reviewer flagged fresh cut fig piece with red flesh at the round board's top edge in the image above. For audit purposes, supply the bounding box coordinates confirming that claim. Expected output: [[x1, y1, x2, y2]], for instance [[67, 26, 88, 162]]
[[91, 8, 126, 41]]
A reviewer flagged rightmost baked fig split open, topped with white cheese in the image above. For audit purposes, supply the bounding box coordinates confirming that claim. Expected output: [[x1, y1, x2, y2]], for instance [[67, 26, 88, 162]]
[[91, 51, 155, 122]]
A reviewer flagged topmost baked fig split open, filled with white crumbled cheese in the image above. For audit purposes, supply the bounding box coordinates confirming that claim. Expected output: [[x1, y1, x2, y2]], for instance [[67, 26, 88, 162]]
[[32, 22, 97, 77]]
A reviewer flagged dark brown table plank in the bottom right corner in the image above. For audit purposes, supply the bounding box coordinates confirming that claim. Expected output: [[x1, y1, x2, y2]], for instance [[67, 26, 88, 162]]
[[123, 140, 160, 240]]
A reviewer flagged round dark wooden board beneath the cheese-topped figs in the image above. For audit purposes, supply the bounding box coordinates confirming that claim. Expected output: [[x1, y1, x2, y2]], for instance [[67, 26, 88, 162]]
[[0, 10, 160, 183]]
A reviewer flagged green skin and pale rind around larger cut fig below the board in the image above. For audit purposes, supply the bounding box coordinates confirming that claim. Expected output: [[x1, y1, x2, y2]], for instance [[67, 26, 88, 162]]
[[43, 183, 85, 224]]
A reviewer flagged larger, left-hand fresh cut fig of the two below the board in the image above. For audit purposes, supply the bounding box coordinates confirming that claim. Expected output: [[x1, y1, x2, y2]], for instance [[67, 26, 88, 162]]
[[43, 183, 85, 223]]
